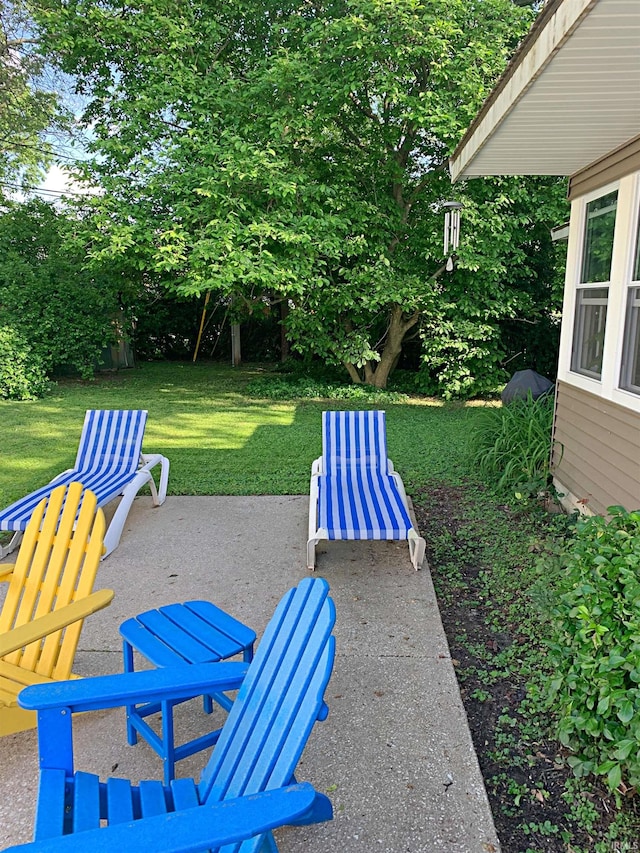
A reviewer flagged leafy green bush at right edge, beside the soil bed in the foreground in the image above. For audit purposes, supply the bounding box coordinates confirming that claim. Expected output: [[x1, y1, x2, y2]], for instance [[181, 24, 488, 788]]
[[546, 507, 640, 791]]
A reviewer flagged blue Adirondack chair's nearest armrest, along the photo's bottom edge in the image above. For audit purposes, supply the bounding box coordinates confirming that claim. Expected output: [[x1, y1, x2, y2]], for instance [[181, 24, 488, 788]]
[[7, 782, 316, 853]]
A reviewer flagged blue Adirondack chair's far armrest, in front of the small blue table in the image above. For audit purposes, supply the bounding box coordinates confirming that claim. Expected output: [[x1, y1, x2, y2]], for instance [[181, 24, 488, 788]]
[[18, 661, 249, 712]]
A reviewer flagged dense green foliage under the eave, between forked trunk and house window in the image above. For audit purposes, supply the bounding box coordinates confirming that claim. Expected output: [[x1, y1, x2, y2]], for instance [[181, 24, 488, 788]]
[[416, 177, 567, 397]]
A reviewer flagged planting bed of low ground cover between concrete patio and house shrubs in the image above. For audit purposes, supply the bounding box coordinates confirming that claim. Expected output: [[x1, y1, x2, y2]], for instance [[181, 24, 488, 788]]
[[413, 486, 640, 853]]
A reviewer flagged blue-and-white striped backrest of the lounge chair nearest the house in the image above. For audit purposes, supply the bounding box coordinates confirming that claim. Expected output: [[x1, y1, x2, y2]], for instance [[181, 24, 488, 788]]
[[322, 411, 389, 475]]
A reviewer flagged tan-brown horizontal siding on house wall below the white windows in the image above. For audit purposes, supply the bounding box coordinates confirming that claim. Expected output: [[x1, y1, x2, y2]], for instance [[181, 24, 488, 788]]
[[554, 382, 640, 514]]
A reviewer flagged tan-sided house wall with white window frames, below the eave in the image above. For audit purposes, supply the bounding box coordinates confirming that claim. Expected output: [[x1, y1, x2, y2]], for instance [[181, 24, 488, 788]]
[[553, 143, 640, 514]]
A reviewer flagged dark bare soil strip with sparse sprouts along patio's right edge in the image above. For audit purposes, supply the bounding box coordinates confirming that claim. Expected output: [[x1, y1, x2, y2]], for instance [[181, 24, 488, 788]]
[[413, 485, 616, 853]]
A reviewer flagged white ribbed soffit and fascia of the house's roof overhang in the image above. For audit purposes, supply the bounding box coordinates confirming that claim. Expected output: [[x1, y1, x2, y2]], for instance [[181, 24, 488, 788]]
[[450, 0, 640, 181]]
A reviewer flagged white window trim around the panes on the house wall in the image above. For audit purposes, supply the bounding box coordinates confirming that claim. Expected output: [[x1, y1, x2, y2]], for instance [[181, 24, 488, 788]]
[[558, 173, 640, 413]]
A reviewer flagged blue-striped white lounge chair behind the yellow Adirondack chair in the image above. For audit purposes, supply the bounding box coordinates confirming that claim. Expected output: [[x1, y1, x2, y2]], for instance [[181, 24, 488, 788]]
[[0, 409, 169, 558]]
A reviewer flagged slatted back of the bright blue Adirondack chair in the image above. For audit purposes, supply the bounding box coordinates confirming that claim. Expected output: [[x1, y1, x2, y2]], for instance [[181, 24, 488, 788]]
[[198, 578, 335, 853]]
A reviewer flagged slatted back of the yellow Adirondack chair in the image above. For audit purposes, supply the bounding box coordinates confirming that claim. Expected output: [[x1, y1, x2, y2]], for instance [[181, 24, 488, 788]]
[[0, 483, 106, 680]]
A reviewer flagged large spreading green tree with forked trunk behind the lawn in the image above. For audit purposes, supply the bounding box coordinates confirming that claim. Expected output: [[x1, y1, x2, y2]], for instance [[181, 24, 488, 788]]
[[36, 0, 564, 387]]
